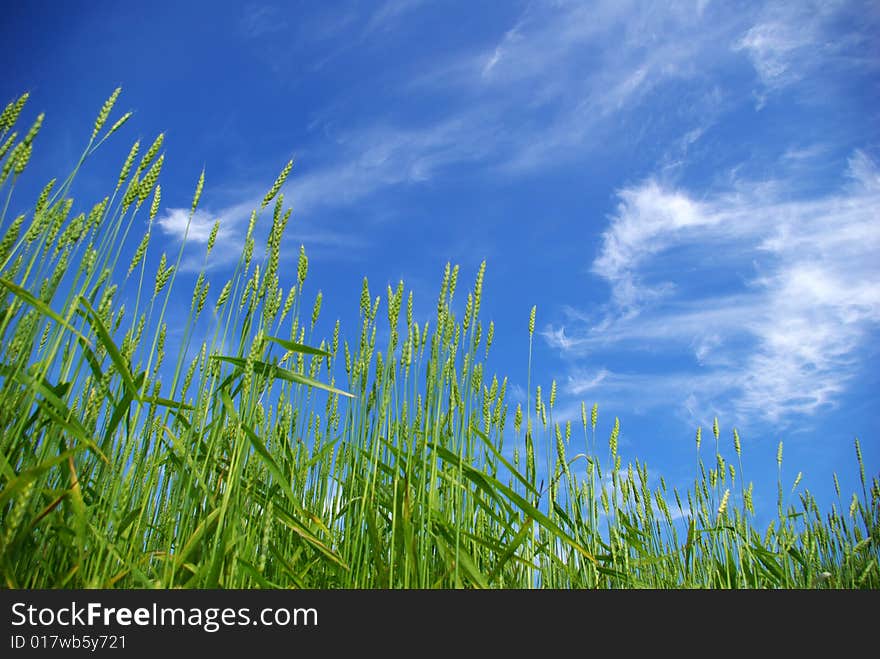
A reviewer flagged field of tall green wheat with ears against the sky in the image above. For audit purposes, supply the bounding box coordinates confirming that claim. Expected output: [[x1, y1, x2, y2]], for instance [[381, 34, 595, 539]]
[[0, 89, 880, 589]]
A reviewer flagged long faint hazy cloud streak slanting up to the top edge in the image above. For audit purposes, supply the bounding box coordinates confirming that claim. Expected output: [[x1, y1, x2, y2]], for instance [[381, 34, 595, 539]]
[[266, 2, 740, 213]]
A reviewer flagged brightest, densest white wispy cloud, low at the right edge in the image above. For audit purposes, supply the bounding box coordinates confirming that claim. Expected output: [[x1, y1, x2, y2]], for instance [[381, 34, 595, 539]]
[[544, 151, 880, 421]]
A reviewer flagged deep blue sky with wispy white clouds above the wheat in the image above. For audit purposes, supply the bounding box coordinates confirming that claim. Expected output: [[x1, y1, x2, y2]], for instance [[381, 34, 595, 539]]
[[0, 0, 880, 510]]
